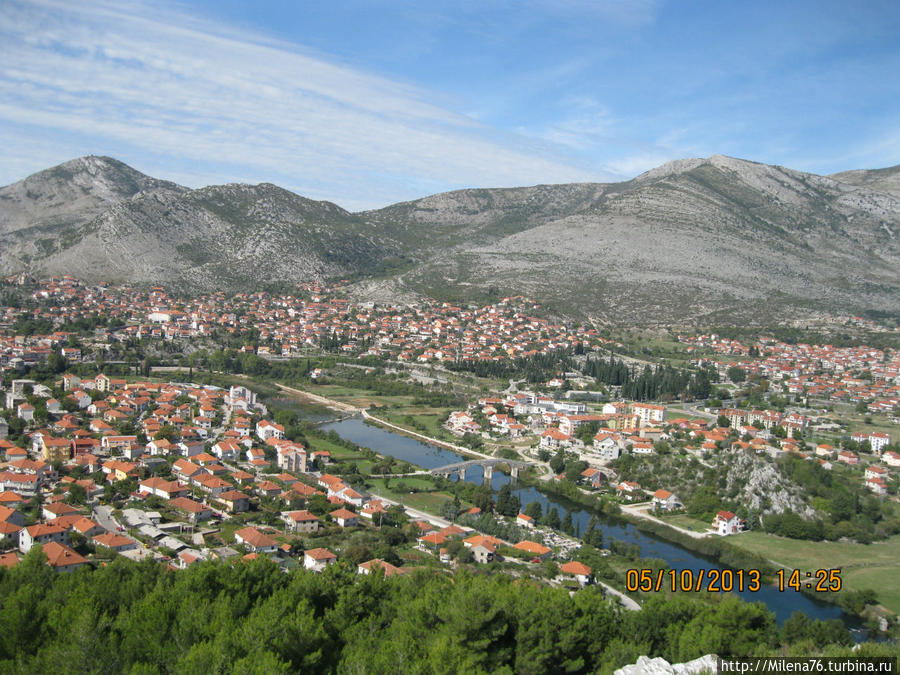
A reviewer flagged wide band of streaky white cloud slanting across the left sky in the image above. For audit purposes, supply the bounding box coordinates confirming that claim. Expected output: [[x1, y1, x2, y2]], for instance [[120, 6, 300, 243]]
[[0, 0, 603, 208]]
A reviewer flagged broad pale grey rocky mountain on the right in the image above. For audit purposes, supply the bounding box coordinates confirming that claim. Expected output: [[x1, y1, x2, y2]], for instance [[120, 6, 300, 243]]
[[363, 156, 900, 323]]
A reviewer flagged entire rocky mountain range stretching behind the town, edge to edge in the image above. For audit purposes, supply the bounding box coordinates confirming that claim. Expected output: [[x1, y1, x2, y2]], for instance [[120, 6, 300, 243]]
[[0, 155, 900, 324]]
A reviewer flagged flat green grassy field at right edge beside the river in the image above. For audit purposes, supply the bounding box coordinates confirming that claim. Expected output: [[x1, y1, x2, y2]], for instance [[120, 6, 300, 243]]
[[728, 532, 900, 613]]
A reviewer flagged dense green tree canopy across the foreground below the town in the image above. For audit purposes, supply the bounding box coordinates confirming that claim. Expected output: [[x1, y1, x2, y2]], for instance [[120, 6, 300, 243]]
[[0, 547, 896, 674]]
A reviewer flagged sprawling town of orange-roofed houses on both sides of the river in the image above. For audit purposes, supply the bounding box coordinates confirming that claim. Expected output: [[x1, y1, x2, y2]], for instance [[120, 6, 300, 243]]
[[0, 277, 900, 616]]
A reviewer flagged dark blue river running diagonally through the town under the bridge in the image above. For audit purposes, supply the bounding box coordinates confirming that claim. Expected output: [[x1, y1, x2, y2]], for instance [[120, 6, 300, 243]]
[[321, 418, 865, 640]]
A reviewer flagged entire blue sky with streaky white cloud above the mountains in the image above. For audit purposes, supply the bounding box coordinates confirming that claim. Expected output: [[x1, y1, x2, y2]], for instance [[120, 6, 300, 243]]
[[0, 0, 900, 210]]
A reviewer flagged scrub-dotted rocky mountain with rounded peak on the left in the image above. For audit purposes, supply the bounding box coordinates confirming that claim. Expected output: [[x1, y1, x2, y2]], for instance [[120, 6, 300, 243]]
[[0, 157, 394, 290]]
